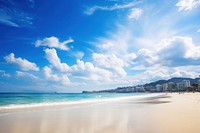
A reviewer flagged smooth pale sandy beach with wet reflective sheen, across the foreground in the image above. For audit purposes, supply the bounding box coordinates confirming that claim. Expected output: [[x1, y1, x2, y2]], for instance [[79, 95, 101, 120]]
[[0, 93, 200, 133]]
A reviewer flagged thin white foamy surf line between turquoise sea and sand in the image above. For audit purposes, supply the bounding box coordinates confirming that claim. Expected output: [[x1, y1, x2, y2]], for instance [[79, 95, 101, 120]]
[[0, 93, 166, 115]]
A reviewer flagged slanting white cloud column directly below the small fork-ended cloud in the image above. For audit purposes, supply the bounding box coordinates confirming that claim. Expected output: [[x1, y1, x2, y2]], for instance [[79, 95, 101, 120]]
[[44, 48, 70, 72]]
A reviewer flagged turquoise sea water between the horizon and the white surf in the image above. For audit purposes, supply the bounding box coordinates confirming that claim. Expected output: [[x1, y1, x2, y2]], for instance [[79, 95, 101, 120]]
[[0, 93, 145, 107]]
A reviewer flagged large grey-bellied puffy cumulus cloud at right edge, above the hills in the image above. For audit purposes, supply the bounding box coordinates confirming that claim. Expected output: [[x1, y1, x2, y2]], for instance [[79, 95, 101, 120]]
[[136, 36, 200, 67]]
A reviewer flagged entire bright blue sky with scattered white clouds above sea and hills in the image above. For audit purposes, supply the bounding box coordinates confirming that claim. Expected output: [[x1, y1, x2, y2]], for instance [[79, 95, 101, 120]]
[[0, 0, 200, 93]]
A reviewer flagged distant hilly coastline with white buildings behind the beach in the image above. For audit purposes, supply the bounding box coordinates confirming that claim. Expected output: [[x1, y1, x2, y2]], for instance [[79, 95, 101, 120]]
[[82, 77, 200, 93]]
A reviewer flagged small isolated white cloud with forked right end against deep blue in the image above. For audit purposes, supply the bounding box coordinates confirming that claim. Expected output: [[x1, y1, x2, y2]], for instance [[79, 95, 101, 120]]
[[35, 36, 74, 51]]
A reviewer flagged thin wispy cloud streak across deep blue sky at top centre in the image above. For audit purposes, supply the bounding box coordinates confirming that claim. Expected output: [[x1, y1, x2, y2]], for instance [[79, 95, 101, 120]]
[[85, 1, 140, 15]]
